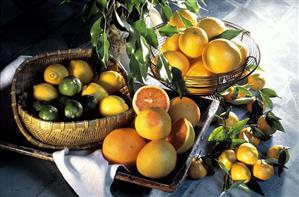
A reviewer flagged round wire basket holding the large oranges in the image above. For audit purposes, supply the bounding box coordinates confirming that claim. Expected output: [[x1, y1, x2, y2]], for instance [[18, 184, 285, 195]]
[[150, 21, 261, 95]]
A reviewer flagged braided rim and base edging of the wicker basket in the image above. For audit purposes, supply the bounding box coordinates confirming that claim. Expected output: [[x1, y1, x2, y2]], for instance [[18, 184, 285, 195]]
[[10, 48, 134, 149]]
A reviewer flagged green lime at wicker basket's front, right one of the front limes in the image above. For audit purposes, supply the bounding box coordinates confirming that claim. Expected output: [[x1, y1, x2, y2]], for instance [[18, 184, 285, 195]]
[[64, 99, 83, 118]]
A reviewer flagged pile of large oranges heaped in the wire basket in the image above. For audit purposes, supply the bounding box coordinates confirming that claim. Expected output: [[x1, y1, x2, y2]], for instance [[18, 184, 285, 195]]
[[161, 9, 248, 77]]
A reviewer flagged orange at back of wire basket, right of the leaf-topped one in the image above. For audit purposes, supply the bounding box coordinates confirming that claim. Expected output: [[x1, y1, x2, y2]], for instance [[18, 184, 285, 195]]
[[197, 17, 226, 40]]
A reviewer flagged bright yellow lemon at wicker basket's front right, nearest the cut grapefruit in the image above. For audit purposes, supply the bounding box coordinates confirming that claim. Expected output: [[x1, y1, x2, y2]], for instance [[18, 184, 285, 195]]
[[99, 95, 129, 116]]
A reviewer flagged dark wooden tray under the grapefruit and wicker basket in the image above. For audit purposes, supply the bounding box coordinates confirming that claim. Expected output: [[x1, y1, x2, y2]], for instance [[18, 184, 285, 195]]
[[0, 96, 219, 192]]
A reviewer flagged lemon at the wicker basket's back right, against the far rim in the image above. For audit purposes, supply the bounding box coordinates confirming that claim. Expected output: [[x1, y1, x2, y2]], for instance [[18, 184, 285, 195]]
[[99, 71, 125, 94]]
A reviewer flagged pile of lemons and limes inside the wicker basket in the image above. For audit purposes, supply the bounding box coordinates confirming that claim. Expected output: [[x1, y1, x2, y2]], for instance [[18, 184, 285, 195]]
[[33, 60, 129, 121]]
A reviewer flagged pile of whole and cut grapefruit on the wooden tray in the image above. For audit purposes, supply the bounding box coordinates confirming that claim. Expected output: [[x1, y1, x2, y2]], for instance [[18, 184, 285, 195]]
[[102, 86, 200, 179]]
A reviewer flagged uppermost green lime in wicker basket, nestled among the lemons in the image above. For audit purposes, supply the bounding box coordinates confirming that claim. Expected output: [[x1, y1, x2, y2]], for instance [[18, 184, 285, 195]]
[[58, 76, 82, 96]]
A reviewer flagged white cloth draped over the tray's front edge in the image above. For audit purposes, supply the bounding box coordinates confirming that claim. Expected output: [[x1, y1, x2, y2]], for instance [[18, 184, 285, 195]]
[[53, 149, 119, 197]]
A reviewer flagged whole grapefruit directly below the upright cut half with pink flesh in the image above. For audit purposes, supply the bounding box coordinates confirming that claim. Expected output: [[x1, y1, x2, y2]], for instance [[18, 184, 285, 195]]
[[135, 108, 171, 140]]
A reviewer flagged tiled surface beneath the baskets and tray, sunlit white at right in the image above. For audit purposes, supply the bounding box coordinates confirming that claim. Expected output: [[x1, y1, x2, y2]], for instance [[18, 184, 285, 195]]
[[0, 0, 299, 197]]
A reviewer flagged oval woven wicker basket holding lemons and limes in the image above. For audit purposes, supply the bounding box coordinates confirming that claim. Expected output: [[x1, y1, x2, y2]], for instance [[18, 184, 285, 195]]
[[11, 49, 134, 149]]
